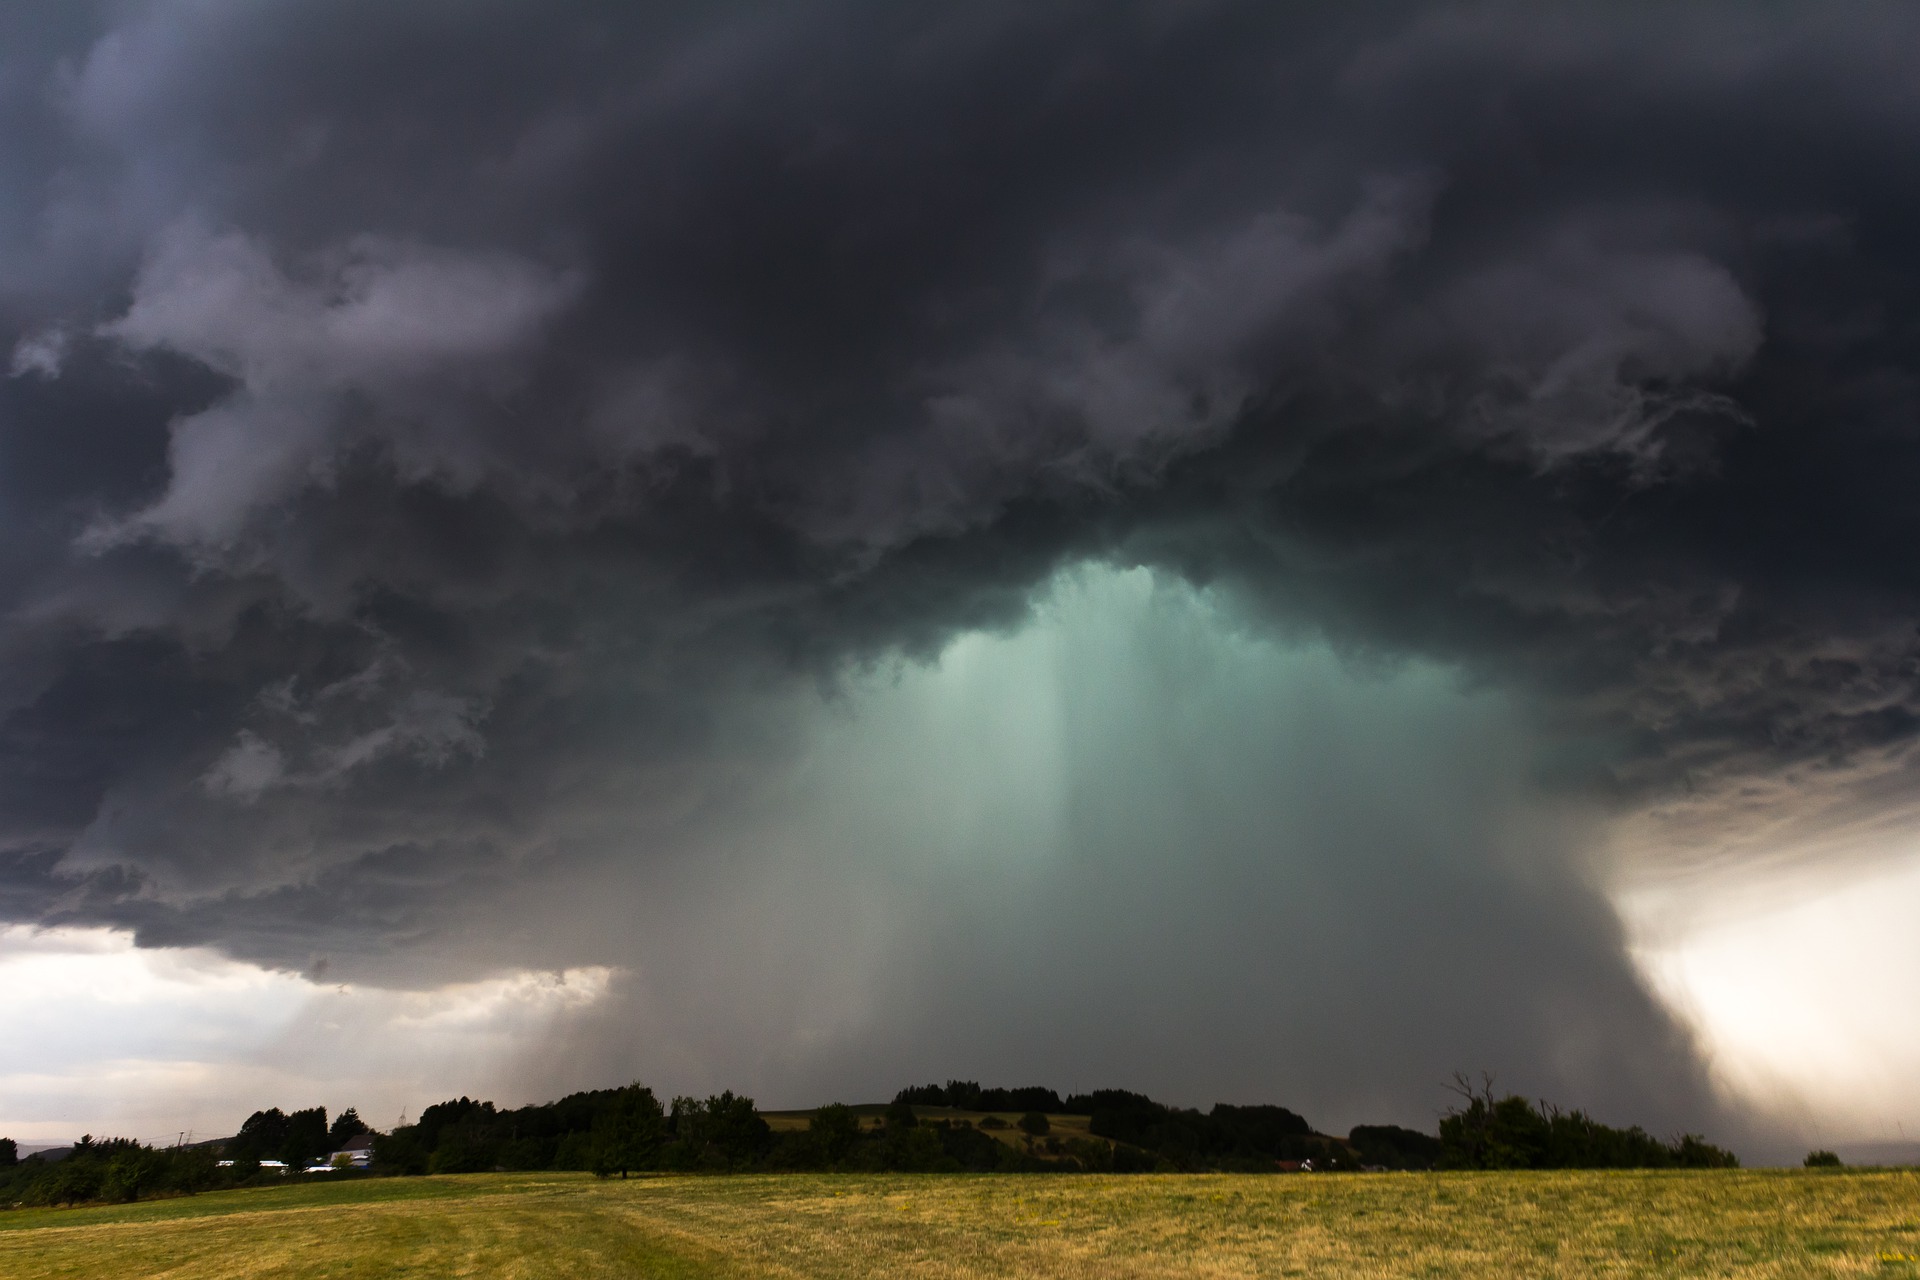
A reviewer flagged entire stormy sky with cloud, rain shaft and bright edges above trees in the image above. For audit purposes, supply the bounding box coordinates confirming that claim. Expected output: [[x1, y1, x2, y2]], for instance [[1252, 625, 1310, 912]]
[[0, 0, 1920, 1159]]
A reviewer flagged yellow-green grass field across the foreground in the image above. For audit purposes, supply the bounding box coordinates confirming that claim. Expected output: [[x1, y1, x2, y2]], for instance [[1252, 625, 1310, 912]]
[[0, 1171, 1920, 1280]]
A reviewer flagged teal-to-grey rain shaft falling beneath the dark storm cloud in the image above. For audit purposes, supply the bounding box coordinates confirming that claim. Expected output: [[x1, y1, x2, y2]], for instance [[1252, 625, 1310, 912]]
[[503, 564, 1715, 1125]]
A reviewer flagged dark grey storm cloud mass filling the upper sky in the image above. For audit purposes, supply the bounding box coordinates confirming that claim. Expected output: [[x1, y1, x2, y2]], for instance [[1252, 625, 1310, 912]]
[[0, 4, 1920, 1143]]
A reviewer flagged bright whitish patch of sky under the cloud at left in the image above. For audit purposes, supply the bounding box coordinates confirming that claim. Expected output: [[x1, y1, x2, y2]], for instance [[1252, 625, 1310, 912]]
[[0, 925, 611, 1146]]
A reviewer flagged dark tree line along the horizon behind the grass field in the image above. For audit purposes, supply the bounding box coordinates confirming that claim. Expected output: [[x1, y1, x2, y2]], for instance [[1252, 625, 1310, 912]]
[[0, 1077, 1738, 1205]]
